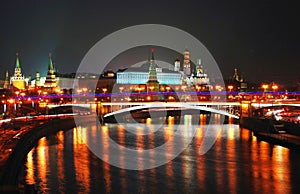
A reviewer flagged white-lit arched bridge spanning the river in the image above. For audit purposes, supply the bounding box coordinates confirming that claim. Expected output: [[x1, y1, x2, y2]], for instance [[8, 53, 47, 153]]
[[48, 101, 300, 122]]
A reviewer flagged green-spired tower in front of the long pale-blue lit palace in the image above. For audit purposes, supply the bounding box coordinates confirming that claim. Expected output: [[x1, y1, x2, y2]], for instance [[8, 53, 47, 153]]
[[146, 48, 159, 92]]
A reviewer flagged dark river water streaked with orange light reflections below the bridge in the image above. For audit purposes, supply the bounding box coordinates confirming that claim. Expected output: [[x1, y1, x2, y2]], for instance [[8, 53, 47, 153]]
[[20, 116, 300, 194]]
